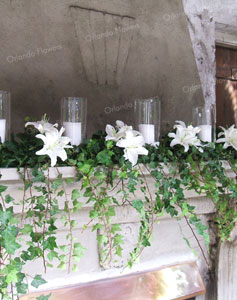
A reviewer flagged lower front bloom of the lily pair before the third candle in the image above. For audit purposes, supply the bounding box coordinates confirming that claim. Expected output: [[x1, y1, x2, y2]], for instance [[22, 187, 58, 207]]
[[116, 130, 148, 166]]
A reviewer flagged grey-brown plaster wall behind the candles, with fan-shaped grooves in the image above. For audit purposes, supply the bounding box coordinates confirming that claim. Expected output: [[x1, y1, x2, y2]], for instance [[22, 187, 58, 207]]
[[0, 0, 204, 136]]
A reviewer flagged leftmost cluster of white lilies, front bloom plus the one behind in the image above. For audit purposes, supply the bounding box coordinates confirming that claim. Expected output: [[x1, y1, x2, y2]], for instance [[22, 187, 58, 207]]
[[25, 118, 72, 167]]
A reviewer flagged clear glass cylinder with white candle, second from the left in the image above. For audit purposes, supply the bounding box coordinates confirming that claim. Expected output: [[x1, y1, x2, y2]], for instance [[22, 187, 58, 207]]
[[61, 97, 87, 146]]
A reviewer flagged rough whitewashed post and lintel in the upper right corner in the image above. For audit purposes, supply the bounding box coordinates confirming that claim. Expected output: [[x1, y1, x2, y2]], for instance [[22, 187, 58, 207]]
[[183, 0, 237, 110]]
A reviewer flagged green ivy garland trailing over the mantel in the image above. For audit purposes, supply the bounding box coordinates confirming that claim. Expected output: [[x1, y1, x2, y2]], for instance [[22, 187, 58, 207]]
[[0, 129, 237, 300]]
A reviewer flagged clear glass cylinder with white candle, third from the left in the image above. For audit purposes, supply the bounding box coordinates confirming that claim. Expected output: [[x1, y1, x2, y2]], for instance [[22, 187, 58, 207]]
[[134, 97, 160, 144]]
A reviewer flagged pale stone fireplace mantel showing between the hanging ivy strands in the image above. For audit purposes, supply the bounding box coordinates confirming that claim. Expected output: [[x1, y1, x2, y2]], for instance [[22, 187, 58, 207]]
[[0, 162, 237, 300]]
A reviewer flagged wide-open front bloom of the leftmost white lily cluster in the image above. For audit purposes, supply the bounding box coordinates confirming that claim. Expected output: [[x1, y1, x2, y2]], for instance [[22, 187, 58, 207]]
[[36, 127, 72, 167]]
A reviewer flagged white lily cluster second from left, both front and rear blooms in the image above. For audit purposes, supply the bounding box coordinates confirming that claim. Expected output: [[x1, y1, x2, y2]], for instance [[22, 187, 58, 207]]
[[105, 120, 148, 166]]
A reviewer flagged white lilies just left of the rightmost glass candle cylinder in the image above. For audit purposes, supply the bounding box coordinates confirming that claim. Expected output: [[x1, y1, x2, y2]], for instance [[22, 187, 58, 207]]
[[168, 121, 203, 152]]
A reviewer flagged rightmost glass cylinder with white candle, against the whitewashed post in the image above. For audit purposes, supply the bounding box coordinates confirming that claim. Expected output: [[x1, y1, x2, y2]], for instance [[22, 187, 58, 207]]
[[193, 105, 216, 143]]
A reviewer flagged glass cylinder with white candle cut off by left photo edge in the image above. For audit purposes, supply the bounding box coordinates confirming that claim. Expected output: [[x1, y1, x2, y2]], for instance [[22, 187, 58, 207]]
[[0, 91, 11, 143]]
